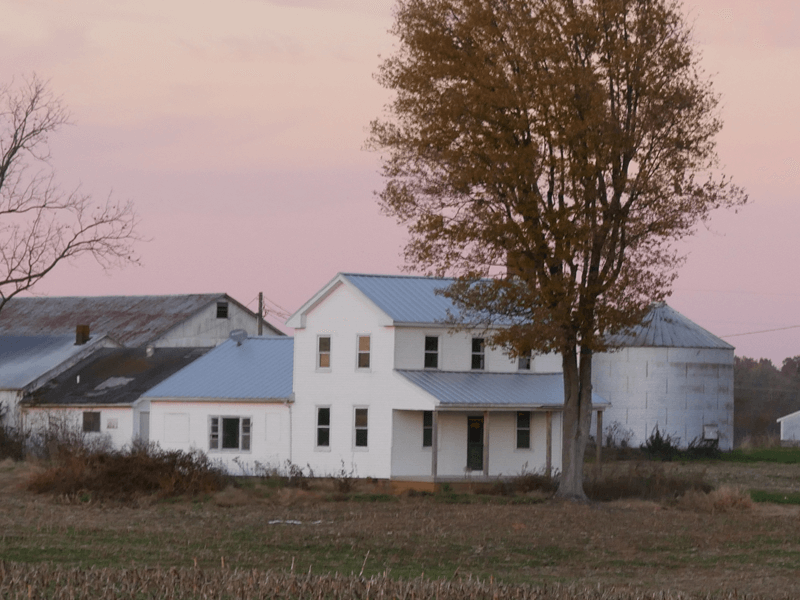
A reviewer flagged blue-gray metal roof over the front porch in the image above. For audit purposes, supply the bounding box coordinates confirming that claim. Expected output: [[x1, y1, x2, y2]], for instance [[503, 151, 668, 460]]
[[397, 369, 608, 408]]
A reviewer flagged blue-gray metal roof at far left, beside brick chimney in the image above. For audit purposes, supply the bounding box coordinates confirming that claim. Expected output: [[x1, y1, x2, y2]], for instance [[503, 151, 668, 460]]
[[0, 333, 111, 390]]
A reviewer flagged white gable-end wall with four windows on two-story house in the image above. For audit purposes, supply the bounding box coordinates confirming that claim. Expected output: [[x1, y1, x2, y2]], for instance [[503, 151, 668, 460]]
[[292, 285, 434, 478]]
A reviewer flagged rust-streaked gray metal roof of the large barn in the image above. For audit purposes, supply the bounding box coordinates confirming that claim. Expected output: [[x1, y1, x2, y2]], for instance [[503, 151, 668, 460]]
[[0, 294, 272, 347]]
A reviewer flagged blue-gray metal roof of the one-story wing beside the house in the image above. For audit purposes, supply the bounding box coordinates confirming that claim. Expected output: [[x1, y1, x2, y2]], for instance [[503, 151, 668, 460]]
[[142, 337, 294, 400]]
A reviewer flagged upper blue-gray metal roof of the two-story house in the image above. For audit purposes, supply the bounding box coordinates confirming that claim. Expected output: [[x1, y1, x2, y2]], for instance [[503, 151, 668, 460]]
[[342, 273, 459, 323]]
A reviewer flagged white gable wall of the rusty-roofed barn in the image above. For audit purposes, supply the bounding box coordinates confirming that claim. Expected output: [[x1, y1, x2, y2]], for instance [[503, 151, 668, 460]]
[[153, 301, 275, 348]]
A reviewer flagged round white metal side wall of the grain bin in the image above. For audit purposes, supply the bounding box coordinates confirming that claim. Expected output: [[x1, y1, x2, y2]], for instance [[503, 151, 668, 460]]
[[592, 348, 734, 450]]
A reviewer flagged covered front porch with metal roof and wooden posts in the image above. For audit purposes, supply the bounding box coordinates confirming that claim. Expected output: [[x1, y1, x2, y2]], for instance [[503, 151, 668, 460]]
[[391, 371, 608, 489]]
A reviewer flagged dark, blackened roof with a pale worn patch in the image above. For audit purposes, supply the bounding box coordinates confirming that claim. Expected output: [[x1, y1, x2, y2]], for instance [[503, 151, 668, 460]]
[[23, 348, 209, 406]]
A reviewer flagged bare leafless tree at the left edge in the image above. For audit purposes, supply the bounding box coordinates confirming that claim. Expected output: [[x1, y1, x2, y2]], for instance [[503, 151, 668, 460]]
[[0, 76, 139, 310]]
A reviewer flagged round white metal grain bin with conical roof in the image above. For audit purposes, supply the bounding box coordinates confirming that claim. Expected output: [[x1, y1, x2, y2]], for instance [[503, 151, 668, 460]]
[[592, 302, 734, 450]]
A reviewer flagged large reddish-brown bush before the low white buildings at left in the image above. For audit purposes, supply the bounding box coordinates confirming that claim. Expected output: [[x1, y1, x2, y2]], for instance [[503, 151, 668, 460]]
[[28, 444, 229, 501]]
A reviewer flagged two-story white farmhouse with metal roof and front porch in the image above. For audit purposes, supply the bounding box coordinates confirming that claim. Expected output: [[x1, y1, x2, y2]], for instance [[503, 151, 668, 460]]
[[287, 273, 607, 482]]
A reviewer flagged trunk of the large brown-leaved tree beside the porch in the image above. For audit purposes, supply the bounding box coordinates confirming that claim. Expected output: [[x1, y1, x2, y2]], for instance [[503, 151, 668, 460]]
[[556, 349, 592, 500]]
